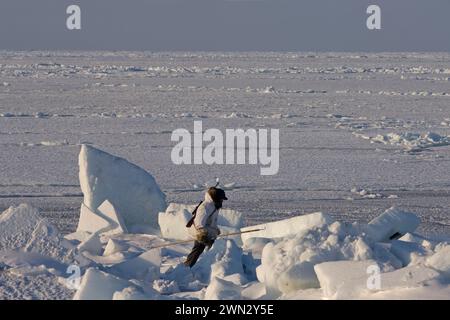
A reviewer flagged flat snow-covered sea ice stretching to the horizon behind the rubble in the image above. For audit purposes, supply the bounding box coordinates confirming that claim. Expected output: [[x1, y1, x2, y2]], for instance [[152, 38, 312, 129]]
[[0, 51, 450, 299]]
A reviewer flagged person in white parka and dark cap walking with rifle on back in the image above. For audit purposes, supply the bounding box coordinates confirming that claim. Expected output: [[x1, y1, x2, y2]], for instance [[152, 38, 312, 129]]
[[184, 187, 228, 267]]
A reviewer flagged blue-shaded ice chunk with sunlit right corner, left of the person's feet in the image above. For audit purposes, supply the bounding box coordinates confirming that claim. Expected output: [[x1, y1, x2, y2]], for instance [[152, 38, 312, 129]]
[[109, 249, 161, 282]]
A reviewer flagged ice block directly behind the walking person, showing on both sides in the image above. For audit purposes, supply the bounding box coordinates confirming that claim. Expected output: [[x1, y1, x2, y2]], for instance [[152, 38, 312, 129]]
[[158, 203, 244, 240]]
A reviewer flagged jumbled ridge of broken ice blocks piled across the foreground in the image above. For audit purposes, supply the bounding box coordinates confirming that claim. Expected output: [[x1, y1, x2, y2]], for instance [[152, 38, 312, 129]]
[[0, 146, 450, 300]]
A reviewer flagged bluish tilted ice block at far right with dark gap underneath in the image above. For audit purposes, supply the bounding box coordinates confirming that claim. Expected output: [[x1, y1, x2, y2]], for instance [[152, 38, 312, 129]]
[[366, 207, 420, 241]]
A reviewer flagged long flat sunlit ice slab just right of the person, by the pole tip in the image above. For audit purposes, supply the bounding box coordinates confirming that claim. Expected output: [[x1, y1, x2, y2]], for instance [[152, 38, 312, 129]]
[[241, 212, 332, 243]]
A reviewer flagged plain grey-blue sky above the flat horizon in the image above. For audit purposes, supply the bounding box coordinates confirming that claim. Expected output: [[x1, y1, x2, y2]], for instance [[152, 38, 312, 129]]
[[0, 0, 450, 51]]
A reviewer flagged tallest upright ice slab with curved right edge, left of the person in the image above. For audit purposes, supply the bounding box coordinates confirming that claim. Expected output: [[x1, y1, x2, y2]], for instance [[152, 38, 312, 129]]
[[79, 145, 166, 231]]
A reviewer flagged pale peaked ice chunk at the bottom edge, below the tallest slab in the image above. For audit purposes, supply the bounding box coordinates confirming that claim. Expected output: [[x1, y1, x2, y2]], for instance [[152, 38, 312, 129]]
[[73, 268, 132, 300]]
